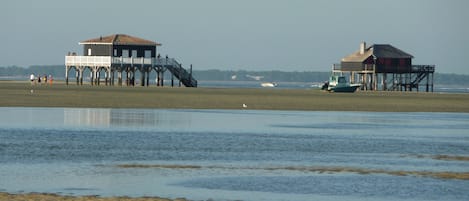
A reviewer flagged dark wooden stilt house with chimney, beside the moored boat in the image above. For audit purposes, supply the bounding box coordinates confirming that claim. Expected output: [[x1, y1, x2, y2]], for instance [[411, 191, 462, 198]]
[[333, 42, 435, 92]]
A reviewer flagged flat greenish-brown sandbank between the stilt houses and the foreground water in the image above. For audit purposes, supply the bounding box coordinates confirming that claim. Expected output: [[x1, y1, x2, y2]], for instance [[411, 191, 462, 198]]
[[0, 81, 469, 113]]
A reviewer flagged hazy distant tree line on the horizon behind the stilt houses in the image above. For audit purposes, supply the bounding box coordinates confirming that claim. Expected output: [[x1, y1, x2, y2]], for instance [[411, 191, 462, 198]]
[[0, 65, 469, 86]]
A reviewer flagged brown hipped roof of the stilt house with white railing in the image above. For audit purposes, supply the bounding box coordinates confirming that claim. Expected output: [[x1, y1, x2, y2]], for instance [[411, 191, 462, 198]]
[[79, 34, 161, 46]]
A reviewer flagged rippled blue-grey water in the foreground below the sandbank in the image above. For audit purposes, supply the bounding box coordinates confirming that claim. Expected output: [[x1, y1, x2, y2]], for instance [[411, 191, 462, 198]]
[[0, 107, 469, 201]]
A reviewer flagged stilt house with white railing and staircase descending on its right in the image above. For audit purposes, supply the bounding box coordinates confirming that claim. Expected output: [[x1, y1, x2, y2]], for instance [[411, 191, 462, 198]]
[[65, 34, 197, 87]]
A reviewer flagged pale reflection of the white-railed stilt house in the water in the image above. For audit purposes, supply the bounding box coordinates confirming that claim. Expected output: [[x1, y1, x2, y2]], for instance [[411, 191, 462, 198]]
[[64, 108, 191, 127]]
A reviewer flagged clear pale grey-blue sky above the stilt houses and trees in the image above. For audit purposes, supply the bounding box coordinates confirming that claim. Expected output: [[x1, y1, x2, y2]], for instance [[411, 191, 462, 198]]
[[0, 0, 469, 74]]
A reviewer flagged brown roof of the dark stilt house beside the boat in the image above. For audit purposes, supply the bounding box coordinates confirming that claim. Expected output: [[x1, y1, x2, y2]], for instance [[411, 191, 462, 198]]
[[342, 44, 414, 62]]
